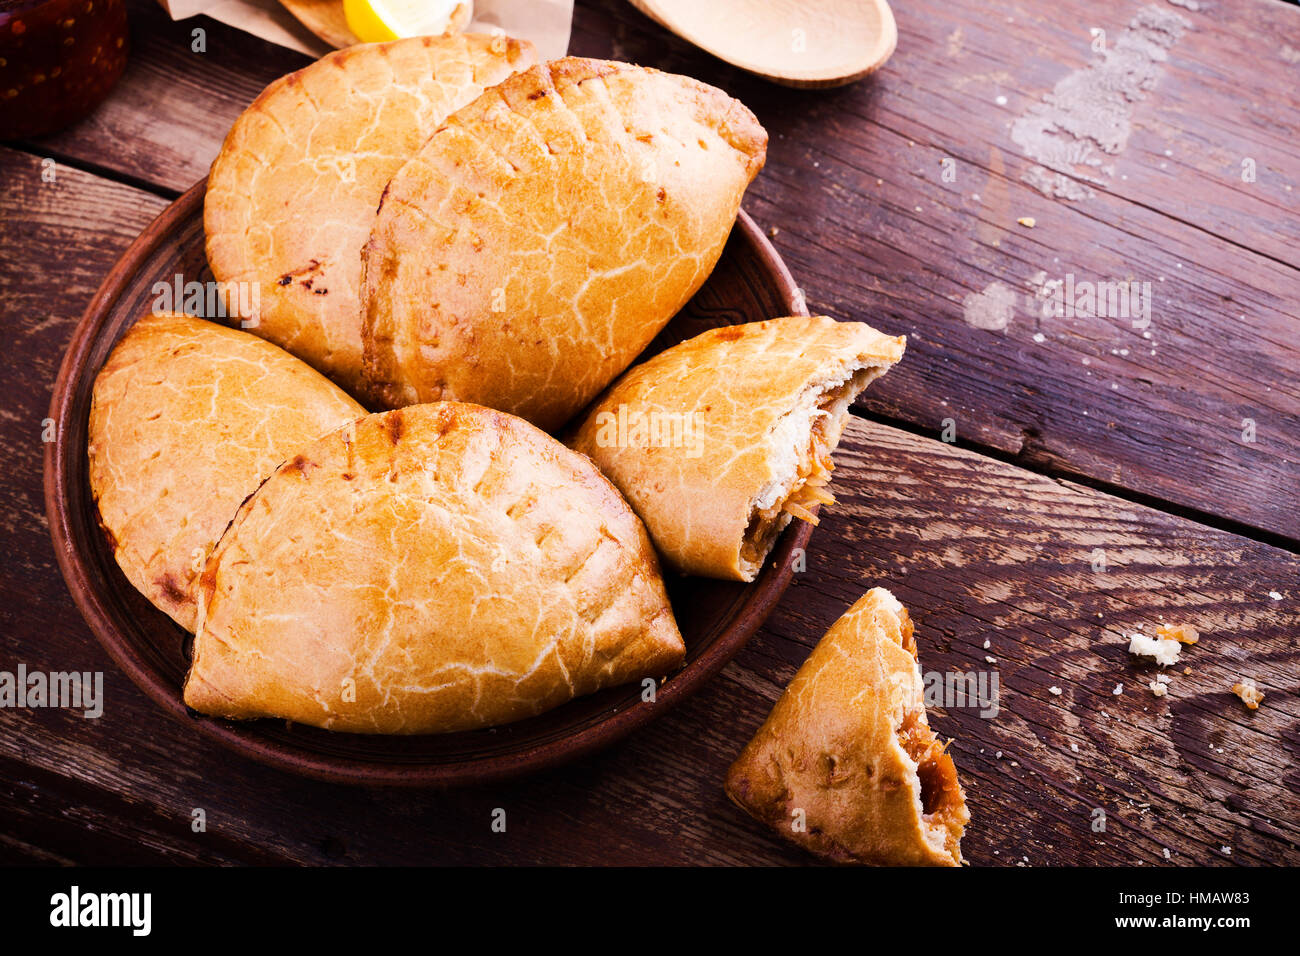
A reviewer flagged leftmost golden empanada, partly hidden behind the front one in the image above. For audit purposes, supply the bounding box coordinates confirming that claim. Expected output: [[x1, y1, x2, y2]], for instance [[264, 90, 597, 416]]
[[87, 312, 365, 631]]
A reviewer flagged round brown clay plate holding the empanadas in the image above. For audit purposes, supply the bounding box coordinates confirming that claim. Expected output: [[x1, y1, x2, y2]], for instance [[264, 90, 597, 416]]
[[46, 181, 811, 786]]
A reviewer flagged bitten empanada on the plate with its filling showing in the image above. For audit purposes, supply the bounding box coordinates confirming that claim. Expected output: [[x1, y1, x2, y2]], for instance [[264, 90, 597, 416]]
[[569, 316, 906, 581]]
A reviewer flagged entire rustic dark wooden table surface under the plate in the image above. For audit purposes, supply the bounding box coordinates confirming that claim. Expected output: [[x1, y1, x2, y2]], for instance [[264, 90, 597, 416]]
[[0, 0, 1300, 866]]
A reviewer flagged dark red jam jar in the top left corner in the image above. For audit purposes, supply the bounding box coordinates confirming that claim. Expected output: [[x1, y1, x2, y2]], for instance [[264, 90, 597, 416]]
[[0, 0, 127, 139]]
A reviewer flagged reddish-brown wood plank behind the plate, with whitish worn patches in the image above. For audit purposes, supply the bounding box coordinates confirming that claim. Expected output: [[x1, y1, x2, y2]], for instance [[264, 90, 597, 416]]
[[22, 0, 1300, 541]]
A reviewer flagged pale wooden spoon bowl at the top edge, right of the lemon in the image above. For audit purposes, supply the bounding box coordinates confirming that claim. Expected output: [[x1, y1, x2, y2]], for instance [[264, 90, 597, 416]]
[[631, 0, 898, 87]]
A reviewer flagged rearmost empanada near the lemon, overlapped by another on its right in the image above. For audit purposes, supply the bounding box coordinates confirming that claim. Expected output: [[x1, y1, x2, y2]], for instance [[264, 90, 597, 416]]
[[204, 34, 537, 394]]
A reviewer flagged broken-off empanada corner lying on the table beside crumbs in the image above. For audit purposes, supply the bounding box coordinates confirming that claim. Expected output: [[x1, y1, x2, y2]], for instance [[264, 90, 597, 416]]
[[725, 588, 970, 866]]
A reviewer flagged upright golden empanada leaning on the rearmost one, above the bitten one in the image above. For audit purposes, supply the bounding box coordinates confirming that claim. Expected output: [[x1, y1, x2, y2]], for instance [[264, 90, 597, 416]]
[[363, 57, 767, 431]]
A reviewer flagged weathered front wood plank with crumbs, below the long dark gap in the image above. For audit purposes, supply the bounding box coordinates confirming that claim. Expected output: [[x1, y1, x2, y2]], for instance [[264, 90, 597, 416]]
[[0, 152, 1300, 864]]
